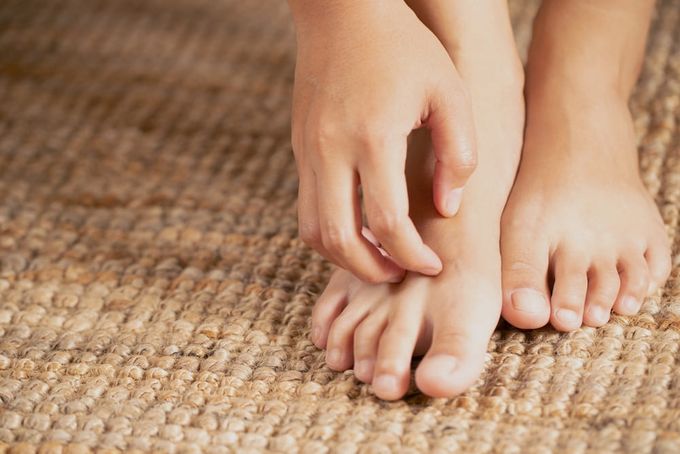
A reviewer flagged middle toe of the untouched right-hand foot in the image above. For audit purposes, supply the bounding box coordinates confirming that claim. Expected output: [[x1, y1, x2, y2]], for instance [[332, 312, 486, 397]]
[[583, 262, 620, 327]]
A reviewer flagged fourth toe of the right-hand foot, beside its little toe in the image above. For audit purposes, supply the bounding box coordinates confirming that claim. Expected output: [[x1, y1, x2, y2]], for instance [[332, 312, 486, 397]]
[[614, 253, 649, 315]]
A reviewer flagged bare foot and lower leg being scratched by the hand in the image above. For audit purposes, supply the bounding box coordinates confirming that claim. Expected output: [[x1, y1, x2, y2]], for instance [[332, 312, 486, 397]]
[[312, 1, 524, 399]]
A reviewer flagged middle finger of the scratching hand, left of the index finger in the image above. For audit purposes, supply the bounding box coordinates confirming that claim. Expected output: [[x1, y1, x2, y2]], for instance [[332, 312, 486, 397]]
[[316, 165, 404, 283]]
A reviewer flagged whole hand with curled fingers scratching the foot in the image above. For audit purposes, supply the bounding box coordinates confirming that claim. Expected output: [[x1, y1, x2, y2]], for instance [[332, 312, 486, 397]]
[[291, 0, 476, 282]]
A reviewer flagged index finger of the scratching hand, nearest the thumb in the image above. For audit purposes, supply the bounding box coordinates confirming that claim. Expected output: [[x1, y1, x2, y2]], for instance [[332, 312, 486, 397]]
[[359, 144, 442, 275]]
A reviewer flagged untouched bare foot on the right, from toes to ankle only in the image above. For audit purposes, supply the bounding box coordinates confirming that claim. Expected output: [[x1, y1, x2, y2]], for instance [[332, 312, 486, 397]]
[[501, 87, 670, 331]]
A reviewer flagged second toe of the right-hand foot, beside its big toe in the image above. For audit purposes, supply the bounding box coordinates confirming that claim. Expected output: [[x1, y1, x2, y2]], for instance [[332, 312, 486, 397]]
[[550, 251, 589, 331]]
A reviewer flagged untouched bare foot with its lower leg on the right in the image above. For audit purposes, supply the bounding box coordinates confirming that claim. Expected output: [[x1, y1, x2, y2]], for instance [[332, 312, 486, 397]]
[[501, 0, 671, 331]]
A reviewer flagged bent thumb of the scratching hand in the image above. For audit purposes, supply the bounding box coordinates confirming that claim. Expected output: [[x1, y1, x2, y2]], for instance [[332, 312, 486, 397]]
[[427, 79, 477, 217]]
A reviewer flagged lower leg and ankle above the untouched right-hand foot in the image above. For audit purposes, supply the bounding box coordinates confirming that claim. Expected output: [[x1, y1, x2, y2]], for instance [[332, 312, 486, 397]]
[[527, 0, 653, 99]]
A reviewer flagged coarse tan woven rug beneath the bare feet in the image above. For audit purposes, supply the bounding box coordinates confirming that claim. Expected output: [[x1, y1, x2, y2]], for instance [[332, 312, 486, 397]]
[[0, 0, 680, 454]]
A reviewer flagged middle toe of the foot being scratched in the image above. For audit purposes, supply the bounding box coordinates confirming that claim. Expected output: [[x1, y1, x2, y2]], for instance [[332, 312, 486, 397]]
[[354, 306, 387, 383]]
